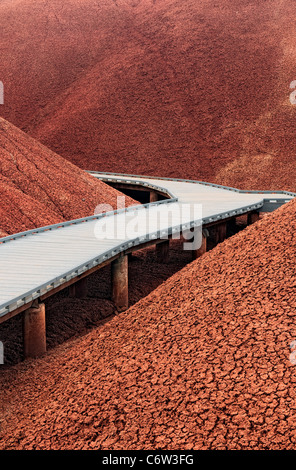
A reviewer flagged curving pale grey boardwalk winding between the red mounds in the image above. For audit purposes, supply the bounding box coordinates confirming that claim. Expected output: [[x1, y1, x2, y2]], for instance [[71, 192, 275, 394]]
[[0, 172, 296, 355]]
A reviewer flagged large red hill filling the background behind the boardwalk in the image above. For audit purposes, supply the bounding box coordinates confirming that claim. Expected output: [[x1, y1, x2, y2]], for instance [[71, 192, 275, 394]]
[[0, 0, 296, 190]]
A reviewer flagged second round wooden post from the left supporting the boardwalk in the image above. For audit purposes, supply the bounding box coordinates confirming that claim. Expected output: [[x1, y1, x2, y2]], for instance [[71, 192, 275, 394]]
[[111, 255, 128, 312]]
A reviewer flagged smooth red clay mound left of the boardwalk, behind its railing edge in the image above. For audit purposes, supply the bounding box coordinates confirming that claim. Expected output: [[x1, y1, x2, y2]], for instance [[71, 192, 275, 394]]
[[0, 119, 136, 236]]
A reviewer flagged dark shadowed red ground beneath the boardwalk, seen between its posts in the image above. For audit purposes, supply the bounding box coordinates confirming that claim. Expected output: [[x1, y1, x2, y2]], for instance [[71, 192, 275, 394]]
[[0, 240, 191, 371]]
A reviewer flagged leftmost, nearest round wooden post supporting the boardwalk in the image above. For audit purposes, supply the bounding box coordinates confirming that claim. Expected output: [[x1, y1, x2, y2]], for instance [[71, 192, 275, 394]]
[[23, 302, 46, 358]]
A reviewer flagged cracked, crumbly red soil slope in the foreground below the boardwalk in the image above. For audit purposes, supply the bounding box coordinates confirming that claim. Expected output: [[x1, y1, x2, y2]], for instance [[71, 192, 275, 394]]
[[0, 201, 296, 450]]
